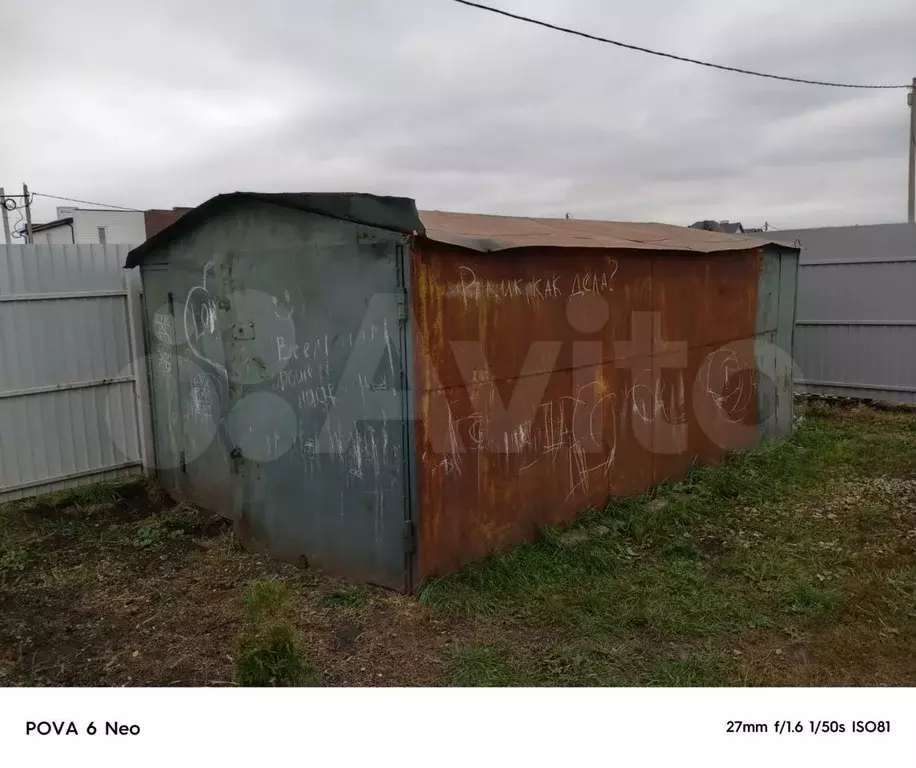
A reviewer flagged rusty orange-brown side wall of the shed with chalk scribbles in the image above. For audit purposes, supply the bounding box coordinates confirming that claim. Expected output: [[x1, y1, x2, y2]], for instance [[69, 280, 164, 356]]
[[411, 240, 778, 579]]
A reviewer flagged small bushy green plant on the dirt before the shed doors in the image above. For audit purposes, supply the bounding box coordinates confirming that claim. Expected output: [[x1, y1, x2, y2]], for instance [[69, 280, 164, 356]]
[[235, 581, 317, 686]]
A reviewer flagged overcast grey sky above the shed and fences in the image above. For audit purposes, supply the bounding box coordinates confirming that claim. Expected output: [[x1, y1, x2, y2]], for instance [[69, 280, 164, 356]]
[[0, 0, 916, 228]]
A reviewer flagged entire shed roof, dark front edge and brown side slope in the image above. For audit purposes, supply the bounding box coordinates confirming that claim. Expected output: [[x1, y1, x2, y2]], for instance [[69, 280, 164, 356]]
[[125, 192, 795, 268]]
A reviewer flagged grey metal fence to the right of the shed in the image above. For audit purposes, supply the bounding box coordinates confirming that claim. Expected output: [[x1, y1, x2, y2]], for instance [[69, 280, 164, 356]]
[[779, 224, 916, 403]]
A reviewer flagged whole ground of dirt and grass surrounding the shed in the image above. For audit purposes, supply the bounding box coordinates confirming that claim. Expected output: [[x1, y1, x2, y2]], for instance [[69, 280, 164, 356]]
[[0, 406, 916, 686]]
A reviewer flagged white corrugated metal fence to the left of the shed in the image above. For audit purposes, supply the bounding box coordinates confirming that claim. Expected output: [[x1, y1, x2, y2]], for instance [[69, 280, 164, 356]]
[[0, 245, 150, 502]]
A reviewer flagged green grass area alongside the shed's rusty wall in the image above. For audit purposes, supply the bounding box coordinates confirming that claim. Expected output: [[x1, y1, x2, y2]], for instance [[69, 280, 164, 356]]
[[420, 405, 916, 685]]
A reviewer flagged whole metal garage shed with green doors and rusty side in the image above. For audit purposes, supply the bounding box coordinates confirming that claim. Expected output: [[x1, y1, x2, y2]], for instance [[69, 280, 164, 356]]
[[126, 193, 798, 591]]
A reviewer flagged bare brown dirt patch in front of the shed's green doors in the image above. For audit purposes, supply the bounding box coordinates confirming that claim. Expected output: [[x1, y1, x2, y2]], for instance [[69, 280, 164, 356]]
[[0, 482, 450, 686]]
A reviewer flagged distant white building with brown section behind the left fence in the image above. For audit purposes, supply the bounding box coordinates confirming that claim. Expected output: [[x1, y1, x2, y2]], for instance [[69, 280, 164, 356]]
[[32, 206, 191, 245]]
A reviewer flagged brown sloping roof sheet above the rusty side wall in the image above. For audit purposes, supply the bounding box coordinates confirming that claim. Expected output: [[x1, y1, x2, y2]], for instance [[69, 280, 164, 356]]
[[420, 211, 795, 253]]
